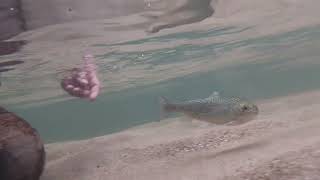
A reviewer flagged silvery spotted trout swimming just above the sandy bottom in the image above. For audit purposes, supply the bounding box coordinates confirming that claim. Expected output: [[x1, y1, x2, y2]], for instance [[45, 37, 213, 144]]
[[160, 92, 259, 125]]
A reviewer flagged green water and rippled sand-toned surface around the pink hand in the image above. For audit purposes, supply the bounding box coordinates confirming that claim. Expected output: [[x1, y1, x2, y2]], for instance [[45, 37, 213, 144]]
[[0, 1, 320, 142]]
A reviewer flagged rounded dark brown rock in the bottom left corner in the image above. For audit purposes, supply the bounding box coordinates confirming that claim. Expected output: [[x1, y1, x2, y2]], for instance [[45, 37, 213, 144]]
[[0, 107, 45, 180]]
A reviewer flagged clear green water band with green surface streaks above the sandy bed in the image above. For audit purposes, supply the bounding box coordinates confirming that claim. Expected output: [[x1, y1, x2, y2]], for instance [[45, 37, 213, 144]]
[[9, 26, 320, 142]]
